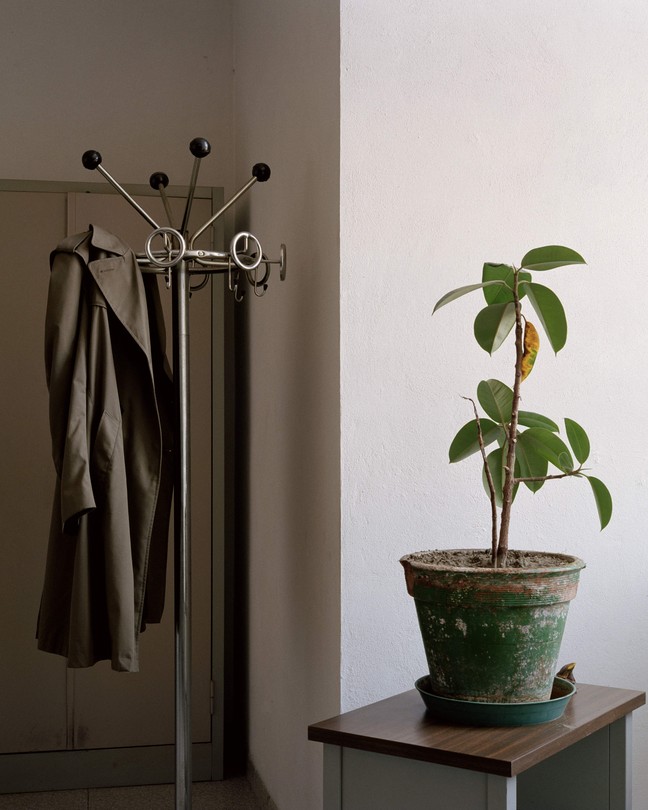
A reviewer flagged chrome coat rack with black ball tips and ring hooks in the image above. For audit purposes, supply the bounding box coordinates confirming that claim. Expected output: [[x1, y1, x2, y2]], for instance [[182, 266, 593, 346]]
[[82, 138, 286, 810]]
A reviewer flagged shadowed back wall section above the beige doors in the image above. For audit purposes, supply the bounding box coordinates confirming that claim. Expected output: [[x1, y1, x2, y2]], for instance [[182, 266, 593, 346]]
[[0, 0, 233, 188]]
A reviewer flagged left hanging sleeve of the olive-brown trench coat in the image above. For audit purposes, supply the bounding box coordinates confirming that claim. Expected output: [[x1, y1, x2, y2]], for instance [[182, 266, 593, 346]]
[[45, 252, 95, 534]]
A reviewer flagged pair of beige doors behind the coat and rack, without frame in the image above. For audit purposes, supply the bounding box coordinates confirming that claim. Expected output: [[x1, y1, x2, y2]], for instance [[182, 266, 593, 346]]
[[0, 184, 228, 792]]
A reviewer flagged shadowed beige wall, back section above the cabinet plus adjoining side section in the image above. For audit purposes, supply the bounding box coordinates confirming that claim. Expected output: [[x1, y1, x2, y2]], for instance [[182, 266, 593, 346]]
[[0, 0, 340, 810]]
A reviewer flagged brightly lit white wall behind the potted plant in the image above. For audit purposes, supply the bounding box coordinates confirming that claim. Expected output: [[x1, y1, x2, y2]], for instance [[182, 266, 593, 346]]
[[340, 0, 648, 796]]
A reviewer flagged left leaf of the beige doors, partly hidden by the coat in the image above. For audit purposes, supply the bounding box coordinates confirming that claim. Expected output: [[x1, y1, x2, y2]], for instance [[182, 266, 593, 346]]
[[0, 192, 66, 753]]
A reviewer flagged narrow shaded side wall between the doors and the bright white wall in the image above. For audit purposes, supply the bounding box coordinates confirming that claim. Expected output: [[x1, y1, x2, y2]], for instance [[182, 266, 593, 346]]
[[234, 0, 340, 810]]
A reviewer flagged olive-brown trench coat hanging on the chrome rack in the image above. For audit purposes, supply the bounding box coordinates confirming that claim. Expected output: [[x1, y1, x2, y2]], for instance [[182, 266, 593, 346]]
[[37, 226, 173, 672]]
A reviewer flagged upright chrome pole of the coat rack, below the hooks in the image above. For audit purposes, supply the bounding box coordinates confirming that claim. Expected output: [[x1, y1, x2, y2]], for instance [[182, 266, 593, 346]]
[[171, 261, 192, 810]]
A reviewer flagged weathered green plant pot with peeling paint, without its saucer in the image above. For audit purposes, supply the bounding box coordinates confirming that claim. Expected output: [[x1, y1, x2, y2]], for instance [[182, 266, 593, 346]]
[[400, 550, 585, 703]]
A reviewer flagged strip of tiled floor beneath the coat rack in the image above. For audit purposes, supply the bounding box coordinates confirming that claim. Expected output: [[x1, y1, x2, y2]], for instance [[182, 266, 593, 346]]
[[0, 777, 267, 810]]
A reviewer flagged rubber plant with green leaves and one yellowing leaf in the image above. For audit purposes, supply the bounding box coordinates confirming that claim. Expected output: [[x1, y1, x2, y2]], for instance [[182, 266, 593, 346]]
[[434, 245, 612, 567]]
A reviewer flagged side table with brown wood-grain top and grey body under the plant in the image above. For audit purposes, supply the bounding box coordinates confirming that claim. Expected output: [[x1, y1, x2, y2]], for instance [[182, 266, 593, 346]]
[[308, 683, 646, 810]]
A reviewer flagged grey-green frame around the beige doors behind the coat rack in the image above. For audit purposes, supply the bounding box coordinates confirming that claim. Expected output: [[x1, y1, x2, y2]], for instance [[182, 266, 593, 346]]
[[0, 179, 233, 794]]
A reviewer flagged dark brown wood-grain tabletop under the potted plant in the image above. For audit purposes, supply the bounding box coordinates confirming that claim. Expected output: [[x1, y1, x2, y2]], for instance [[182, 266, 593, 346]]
[[308, 683, 646, 776]]
